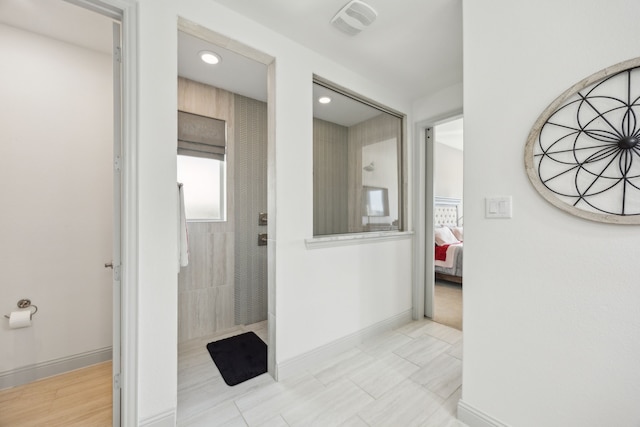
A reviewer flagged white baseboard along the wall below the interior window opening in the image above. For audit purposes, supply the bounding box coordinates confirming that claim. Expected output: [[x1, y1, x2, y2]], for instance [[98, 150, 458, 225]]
[[275, 310, 411, 381]]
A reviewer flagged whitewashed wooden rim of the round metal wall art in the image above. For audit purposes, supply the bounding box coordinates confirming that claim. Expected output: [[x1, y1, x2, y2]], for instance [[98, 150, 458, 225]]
[[524, 58, 640, 224]]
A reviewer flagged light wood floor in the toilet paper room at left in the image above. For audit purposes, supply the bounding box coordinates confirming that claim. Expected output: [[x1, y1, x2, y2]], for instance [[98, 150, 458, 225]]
[[0, 362, 112, 427]]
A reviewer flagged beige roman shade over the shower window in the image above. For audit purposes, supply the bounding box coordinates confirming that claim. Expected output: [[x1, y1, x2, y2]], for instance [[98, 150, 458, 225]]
[[178, 111, 227, 160]]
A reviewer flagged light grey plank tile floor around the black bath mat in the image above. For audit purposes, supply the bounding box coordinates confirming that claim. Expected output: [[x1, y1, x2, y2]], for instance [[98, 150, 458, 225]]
[[178, 319, 464, 427]]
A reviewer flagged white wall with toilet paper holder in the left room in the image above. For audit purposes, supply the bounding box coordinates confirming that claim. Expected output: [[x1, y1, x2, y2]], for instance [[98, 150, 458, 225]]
[[0, 25, 113, 374]]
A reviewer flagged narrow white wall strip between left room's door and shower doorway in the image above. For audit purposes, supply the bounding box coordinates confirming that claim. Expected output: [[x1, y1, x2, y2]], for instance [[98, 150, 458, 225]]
[[138, 0, 178, 420]]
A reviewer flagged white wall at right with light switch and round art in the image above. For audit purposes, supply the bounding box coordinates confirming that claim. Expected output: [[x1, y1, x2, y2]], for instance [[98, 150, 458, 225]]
[[462, 0, 640, 427]]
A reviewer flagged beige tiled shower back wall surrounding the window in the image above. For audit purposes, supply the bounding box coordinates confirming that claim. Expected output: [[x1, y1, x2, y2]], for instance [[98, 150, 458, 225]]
[[178, 78, 235, 342]]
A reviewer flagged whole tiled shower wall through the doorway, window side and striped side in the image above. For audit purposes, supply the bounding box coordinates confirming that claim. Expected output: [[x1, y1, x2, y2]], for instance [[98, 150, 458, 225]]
[[178, 78, 267, 342]]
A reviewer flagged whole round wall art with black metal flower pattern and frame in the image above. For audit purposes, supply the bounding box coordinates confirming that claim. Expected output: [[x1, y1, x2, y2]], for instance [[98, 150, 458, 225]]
[[525, 58, 640, 224]]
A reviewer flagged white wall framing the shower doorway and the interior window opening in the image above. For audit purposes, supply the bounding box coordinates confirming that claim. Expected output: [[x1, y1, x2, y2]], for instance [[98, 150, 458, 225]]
[[138, 0, 412, 419]]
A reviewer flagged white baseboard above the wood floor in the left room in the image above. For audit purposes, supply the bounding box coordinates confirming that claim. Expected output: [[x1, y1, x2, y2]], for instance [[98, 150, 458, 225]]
[[0, 347, 112, 390]]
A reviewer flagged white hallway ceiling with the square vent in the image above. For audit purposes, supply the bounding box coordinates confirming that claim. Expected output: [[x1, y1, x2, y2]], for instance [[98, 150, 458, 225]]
[[214, 0, 462, 100]]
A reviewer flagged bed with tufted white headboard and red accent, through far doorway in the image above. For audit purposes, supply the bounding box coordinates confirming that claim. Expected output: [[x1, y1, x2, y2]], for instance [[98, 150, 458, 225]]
[[433, 197, 464, 283]]
